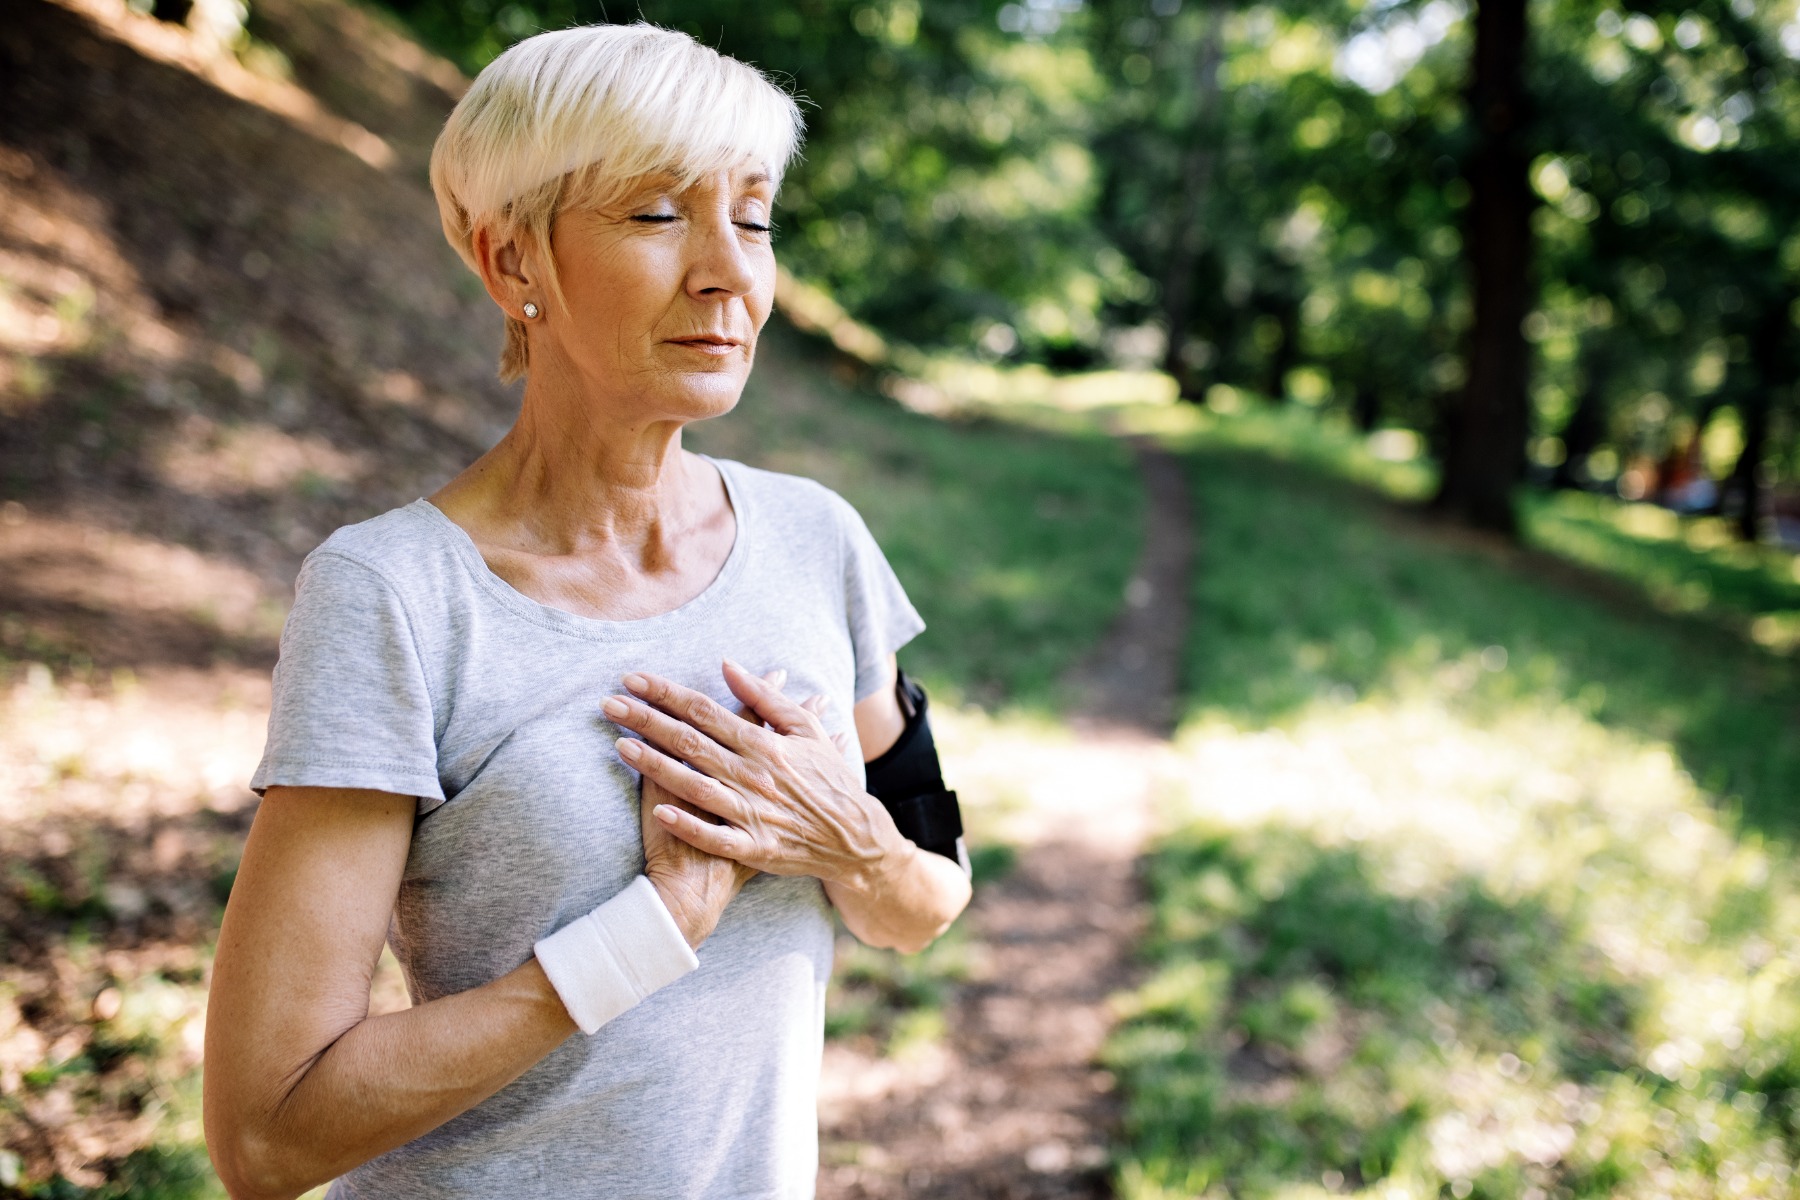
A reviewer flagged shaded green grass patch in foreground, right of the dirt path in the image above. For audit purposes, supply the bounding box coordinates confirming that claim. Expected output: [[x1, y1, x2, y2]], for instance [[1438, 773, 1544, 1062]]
[[1111, 828, 1663, 1196]]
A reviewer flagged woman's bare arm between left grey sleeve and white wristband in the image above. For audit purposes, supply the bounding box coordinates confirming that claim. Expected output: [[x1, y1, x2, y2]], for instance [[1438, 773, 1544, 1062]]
[[205, 788, 734, 1200]]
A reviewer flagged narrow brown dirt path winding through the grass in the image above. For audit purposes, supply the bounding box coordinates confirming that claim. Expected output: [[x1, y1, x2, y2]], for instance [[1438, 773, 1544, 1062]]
[[819, 443, 1193, 1200]]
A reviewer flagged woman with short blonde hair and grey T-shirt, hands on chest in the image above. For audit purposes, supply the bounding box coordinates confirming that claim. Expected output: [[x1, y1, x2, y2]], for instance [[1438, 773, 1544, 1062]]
[[205, 25, 968, 1198]]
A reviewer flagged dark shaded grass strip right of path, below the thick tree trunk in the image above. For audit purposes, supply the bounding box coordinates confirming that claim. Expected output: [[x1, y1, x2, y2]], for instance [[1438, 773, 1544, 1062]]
[[1188, 448, 1800, 831]]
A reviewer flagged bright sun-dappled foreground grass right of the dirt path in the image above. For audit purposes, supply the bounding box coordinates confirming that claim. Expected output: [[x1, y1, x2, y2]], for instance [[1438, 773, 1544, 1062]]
[[1114, 680, 1800, 1200]]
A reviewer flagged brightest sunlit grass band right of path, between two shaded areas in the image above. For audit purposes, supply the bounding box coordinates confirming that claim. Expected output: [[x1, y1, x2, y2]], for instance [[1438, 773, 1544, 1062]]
[[1181, 683, 1800, 1007]]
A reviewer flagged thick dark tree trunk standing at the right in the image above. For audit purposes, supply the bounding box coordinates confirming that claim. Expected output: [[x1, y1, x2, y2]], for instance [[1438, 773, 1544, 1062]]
[[1436, 0, 1532, 534]]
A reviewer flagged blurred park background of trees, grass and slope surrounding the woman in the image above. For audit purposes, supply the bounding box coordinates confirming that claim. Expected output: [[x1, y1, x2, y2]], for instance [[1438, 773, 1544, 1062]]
[[0, 0, 1800, 1200]]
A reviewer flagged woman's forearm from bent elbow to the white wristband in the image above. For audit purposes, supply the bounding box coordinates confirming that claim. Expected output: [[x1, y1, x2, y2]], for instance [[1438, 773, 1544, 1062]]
[[209, 959, 576, 1200]]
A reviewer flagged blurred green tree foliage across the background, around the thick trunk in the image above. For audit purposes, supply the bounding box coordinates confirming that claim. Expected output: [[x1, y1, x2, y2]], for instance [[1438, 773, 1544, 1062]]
[[365, 0, 1800, 510]]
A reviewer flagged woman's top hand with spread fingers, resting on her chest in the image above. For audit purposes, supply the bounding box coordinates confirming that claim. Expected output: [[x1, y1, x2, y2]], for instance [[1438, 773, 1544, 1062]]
[[605, 660, 900, 891]]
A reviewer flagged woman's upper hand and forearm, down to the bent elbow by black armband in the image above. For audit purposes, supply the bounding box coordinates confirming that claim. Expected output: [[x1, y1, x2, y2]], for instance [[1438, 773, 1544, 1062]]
[[607, 664, 970, 952]]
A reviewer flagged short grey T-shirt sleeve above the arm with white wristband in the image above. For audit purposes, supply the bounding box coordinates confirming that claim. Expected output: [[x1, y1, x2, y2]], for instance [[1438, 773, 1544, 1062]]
[[250, 551, 445, 804]]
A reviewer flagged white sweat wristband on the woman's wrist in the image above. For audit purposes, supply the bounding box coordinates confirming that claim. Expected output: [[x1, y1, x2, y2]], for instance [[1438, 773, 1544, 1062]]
[[535, 874, 700, 1033]]
